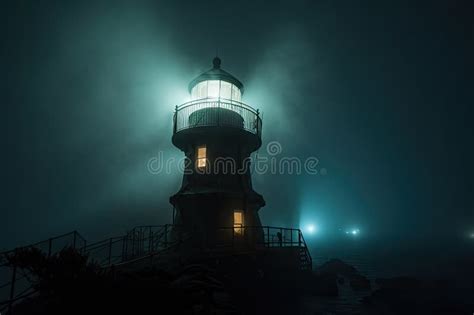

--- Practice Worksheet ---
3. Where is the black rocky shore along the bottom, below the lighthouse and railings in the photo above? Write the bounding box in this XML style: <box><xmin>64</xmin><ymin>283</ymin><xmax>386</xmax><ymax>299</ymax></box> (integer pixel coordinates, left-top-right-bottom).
<box><xmin>4</xmin><ymin>251</ymin><xmax>474</xmax><ymax>315</ymax></box>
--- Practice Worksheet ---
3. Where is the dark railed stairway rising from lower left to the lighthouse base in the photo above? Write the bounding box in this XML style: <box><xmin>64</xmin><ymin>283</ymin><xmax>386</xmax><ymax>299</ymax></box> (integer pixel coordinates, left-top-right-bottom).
<box><xmin>0</xmin><ymin>224</ymin><xmax>179</xmax><ymax>314</ymax></box>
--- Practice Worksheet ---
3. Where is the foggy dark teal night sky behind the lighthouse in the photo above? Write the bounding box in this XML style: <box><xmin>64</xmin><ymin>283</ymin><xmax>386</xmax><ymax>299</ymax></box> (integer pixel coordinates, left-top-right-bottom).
<box><xmin>0</xmin><ymin>0</ymin><xmax>474</xmax><ymax>249</ymax></box>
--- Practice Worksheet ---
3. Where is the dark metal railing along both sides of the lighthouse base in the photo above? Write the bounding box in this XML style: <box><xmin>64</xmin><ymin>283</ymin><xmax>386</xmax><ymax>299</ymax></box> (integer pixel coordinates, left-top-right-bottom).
<box><xmin>0</xmin><ymin>224</ymin><xmax>312</xmax><ymax>314</ymax></box>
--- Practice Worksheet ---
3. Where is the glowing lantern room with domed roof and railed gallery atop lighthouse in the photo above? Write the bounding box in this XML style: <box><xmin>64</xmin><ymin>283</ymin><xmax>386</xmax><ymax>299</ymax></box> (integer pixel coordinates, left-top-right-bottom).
<box><xmin>173</xmin><ymin>57</ymin><xmax>262</xmax><ymax>151</ymax></box>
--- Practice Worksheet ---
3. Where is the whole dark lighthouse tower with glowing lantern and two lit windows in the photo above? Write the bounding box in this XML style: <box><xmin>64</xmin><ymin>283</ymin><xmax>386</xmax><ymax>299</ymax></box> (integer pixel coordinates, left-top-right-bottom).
<box><xmin>170</xmin><ymin>57</ymin><xmax>265</xmax><ymax>246</ymax></box>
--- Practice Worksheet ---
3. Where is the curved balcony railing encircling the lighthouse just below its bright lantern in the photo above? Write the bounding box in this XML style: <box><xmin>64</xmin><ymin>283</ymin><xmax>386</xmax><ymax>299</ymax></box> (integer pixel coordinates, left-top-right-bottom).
<box><xmin>173</xmin><ymin>98</ymin><xmax>262</xmax><ymax>137</ymax></box>
